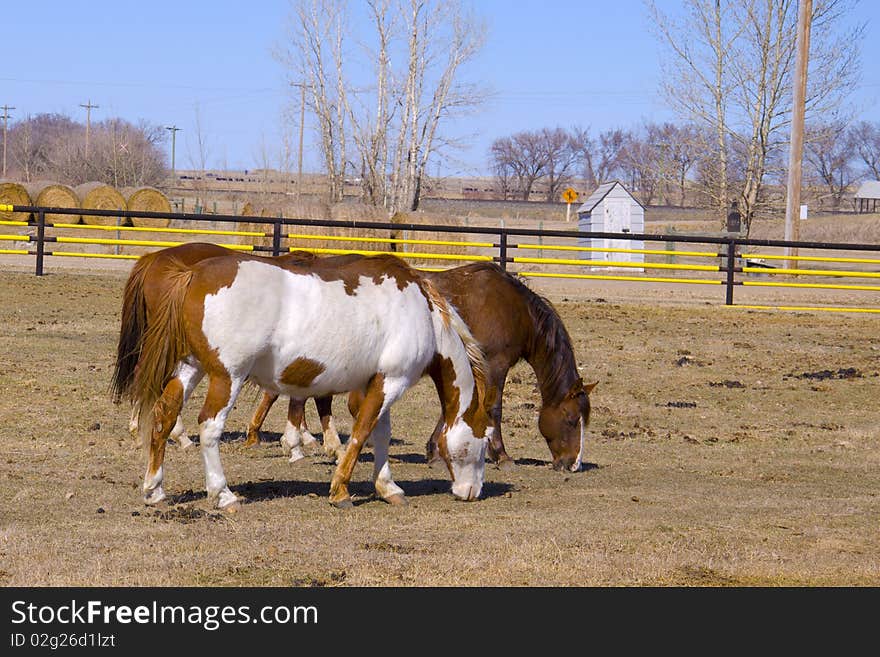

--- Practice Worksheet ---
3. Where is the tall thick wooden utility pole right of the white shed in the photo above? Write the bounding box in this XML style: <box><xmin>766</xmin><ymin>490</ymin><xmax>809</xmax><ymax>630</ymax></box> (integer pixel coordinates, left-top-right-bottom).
<box><xmin>785</xmin><ymin>0</ymin><xmax>813</xmax><ymax>269</ymax></box>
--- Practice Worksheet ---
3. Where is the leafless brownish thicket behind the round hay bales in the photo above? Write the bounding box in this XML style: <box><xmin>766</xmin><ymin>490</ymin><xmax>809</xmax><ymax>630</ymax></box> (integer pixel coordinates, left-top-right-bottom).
<box><xmin>6</xmin><ymin>114</ymin><xmax>167</xmax><ymax>187</ymax></box>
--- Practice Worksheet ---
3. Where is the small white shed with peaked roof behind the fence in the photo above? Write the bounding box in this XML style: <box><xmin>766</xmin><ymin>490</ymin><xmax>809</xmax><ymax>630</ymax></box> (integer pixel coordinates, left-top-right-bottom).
<box><xmin>577</xmin><ymin>181</ymin><xmax>645</xmax><ymax>271</ymax></box>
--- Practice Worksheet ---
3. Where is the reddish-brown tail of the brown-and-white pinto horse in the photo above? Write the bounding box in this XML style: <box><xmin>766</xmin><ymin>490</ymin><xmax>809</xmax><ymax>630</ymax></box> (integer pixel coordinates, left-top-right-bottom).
<box><xmin>129</xmin><ymin>258</ymin><xmax>193</xmax><ymax>441</ymax></box>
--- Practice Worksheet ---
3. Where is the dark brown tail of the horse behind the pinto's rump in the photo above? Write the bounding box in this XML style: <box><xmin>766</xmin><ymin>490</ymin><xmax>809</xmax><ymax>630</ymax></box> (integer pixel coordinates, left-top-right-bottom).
<box><xmin>110</xmin><ymin>251</ymin><xmax>158</xmax><ymax>403</ymax></box>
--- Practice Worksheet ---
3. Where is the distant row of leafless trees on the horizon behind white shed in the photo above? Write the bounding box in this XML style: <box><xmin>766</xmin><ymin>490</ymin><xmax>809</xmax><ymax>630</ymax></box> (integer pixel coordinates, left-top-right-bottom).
<box><xmin>489</xmin><ymin>121</ymin><xmax>880</xmax><ymax>209</ymax></box>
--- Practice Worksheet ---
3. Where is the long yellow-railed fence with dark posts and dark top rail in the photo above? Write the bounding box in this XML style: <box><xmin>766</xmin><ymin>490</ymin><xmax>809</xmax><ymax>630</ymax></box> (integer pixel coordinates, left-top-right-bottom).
<box><xmin>0</xmin><ymin>204</ymin><xmax>880</xmax><ymax>313</ymax></box>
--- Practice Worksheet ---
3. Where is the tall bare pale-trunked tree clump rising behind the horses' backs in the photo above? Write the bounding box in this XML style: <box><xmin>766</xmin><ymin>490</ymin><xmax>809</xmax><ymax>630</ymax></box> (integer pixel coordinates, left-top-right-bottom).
<box><xmin>279</xmin><ymin>0</ymin><xmax>485</xmax><ymax>214</ymax></box>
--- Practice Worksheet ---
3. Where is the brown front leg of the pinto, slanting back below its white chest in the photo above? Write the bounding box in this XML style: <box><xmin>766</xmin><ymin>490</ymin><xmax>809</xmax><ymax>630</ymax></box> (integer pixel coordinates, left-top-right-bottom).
<box><xmin>330</xmin><ymin>373</ymin><xmax>409</xmax><ymax>508</ymax></box>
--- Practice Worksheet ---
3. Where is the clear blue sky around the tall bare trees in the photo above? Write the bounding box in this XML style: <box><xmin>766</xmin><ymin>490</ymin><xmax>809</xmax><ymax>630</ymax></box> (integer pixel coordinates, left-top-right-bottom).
<box><xmin>6</xmin><ymin>0</ymin><xmax>880</xmax><ymax>175</ymax></box>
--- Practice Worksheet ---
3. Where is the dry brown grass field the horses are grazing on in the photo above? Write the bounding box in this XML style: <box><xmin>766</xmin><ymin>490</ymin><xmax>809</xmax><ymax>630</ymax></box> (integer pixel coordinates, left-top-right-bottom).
<box><xmin>0</xmin><ymin>255</ymin><xmax>880</xmax><ymax>586</ymax></box>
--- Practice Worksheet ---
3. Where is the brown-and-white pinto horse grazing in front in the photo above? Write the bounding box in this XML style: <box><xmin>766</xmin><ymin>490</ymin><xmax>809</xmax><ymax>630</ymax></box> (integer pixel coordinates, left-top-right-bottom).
<box><xmin>114</xmin><ymin>247</ymin><xmax>492</xmax><ymax>508</ymax></box>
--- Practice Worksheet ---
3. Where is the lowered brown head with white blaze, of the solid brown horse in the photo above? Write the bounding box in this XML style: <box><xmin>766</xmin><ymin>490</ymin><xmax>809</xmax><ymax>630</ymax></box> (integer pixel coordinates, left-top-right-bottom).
<box><xmin>538</xmin><ymin>379</ymin><xmax>598</xmax><ymax>472</ymax></box>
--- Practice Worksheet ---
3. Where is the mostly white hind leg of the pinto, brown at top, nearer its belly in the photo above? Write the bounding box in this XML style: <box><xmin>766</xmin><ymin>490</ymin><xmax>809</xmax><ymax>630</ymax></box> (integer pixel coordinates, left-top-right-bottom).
<box><xmin>199</xmin><ymin>374</ymin><xmax>243</xmax><ymax>511</ymax></box>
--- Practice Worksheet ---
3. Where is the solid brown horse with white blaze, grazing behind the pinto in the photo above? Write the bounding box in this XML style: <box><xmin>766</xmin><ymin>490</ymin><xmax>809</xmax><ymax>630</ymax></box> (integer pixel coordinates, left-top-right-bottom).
<box><xmin>249</xmin><ymin>263</ymin><xmax>596</xmax><ymax>471</ymax></box>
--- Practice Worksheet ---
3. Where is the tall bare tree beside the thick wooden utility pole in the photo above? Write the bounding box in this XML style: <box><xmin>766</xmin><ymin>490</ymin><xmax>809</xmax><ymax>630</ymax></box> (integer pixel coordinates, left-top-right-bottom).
<box><xmin>650</xmin><ymin>0</ymin><xmax>863</xmax><ymax>236</ymax></box>
